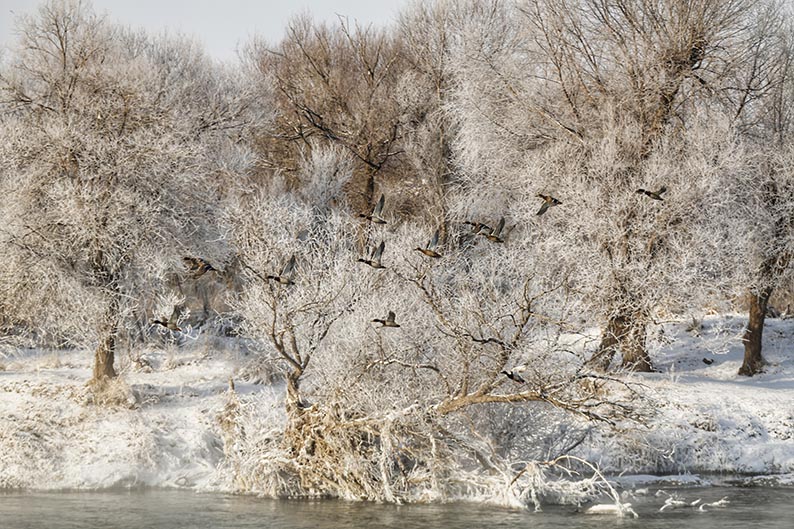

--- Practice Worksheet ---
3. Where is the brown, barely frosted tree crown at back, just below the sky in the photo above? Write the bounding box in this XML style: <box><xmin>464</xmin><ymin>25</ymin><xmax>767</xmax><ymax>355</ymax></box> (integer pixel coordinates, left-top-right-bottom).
<box><xmin>251</xmin><ymin>17</ymin><xmax>404</xmax><ymax>214</ymax></box>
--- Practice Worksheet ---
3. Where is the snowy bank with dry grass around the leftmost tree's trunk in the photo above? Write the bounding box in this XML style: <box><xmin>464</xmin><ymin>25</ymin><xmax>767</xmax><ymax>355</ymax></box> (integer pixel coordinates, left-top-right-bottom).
<box><xmin>0</xmin><ymin>340</ymin><xmax>252</xmax><ymax>489</ymax></box>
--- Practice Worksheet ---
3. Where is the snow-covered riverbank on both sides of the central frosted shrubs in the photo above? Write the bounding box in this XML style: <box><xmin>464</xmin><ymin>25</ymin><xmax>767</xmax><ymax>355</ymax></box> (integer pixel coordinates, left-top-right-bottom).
<box><xmin>0</xmin><ymin>315</ymin><xmax>794</xmax><ymax>491</ymax></box>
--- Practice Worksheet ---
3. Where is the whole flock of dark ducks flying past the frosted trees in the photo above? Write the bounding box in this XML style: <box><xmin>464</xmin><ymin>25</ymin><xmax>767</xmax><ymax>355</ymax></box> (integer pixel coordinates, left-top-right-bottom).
<box><xmin>152</xmin><ymin>186</ymin><xmax>667</xmax><ymax>384</ymax></box>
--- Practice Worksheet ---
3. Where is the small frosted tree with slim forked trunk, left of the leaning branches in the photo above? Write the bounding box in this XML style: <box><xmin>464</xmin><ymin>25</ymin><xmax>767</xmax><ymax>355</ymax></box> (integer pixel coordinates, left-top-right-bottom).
<box><xmin>226</xmin><ymin>148</ymin><xmax>357</xmax><ymax>414</ymax></box>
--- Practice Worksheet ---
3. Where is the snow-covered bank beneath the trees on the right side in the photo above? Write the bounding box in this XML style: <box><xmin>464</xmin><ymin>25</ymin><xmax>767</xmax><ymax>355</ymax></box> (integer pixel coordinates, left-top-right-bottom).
<box><xmin>580</xmin><ymin>315</ymin><xmax>794</xmax><ymax>483</ymax></box>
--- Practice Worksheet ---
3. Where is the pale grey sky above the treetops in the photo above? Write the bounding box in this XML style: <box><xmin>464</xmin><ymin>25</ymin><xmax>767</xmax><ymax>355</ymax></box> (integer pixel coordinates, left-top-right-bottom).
<box><xmin>0</xmin><ymin>0</ymin><xmax>409</xmax><ymax>60</ymax></box>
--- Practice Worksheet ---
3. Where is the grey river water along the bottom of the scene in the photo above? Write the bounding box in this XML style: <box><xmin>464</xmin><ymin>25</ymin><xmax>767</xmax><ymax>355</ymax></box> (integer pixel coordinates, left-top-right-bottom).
<box><xmin>0</xmin><ymin>487</ymin><xmax>794</xmax><ymax>529</ymax></box>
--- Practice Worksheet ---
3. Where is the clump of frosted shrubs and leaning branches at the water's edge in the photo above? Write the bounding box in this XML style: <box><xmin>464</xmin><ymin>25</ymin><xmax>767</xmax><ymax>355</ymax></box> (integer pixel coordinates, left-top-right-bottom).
<box><xmin>220</xmin><ymin>141</ymin><xmax>637</xmax><ymax>501</ymax></box>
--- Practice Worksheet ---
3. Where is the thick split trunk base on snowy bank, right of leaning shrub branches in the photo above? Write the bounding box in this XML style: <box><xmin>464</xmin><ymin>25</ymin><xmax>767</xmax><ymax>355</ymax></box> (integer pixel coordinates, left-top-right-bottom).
<box><xmin>587</xmin><ymin>313</ymin><xmax>653</xmax><ymax>372</ymax></box>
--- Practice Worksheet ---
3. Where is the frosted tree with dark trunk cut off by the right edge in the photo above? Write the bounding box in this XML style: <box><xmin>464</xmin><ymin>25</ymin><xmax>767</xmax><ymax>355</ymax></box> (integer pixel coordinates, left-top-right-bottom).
<box><xmin>715</xmin><ymin>9</ymin><xmax>794</xmax><ymax>376</ymax></box>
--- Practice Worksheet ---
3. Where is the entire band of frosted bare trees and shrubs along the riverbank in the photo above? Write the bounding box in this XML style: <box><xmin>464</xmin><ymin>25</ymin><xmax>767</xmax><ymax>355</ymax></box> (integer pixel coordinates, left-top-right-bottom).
<box><xmin>0</xmin><ymin>0</ymin><xmax>794</xmax><ymax>500</ymax></box>
